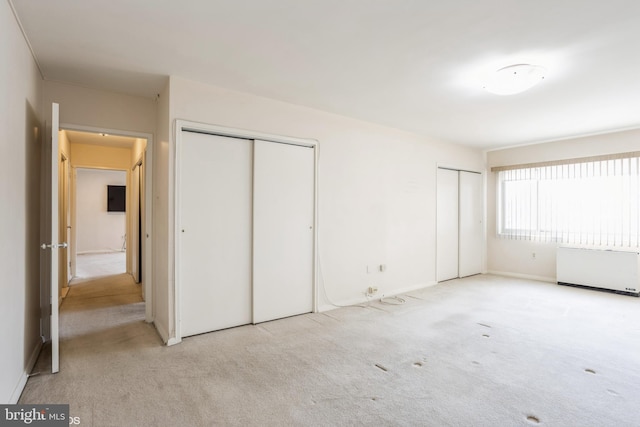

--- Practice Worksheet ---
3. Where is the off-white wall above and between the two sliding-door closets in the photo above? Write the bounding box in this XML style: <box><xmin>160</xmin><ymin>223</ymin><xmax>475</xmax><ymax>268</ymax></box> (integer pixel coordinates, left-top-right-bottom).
<box><xmin>156</xmin><ymin>77</ymin><xmax>484</xmax><ymax>344</ymax></box>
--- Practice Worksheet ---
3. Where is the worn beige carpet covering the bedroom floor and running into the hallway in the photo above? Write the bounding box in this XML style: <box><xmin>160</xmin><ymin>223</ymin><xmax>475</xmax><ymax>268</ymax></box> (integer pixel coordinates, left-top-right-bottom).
<box><xmin>20</xmin><ymin>276</ymin><xmax>640</xmax><ymax>426</ymax></box>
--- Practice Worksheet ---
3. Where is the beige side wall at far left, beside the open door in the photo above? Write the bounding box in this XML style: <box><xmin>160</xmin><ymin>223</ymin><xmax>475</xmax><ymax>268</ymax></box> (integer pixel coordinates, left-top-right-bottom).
<box><xmin>0</xmin><ymin>1</ymin><xmax>44</xmax><ymax>403</ymax></box>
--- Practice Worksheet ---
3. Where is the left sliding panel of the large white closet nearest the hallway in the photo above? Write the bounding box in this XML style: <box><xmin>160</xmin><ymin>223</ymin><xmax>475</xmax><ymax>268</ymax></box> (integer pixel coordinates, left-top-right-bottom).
<box><xmin>177</xmin><ymin>132</ymin><xmax>252</xmax><ymax>337</ymax></box>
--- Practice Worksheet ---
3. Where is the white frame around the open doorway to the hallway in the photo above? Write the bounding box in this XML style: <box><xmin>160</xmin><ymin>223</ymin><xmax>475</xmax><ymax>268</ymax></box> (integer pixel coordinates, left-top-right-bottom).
<box><xmin>60</xmin><ymin>123</ymin><xmax>155</xmax><ymax>323</ymax></box>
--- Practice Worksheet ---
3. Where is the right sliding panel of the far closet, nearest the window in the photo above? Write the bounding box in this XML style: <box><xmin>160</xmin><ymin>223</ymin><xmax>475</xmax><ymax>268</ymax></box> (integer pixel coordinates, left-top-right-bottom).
<box><xmin>458</xmin><ymin>171</ymin><xmax>484</xmax><ymax>277</ymax></box>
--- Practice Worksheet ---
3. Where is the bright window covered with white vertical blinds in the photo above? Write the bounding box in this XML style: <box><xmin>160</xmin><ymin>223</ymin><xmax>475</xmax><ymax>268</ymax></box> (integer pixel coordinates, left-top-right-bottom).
<box><xmin>493</xmin><ymin>153</ymin><xmax>640</xmax><ymax>247</ymax></box>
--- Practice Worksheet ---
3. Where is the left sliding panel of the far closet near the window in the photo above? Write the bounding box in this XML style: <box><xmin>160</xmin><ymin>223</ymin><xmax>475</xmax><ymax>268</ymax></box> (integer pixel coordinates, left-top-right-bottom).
<box><xmin>436</xmin><ymin>168</ymin><xmax>459</xmax><ymax>282</ymax></box>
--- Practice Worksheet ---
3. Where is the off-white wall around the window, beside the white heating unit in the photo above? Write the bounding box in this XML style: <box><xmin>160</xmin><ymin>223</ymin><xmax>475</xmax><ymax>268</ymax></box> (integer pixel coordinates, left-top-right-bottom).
<box><xmin>487</xmin><ymin>130</ymin><xmax>640</xmax><ymax>281</ymax></box>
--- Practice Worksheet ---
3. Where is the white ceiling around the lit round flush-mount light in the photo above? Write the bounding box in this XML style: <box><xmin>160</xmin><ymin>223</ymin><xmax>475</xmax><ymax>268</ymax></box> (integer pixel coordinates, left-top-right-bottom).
<box><xmin>10</xmin><ymin>0</ymin><xmax>640</xmax><ymax>148</ymax></box>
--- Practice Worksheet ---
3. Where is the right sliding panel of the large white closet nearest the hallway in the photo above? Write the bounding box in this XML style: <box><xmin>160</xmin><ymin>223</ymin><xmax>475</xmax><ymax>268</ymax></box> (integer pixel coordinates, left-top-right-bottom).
<box><xmin>253</xmin><ymin>141</ymin><xmax>314</xmax><ymax>323</ymax></box>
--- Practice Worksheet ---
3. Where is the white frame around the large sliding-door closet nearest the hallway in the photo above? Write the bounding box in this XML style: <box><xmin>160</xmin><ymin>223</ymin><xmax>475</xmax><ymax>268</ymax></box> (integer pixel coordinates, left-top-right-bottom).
<box><xmin>167</xmin><ymin>119</ymin><xmax>319</xmax><ymax>345</ymax></box>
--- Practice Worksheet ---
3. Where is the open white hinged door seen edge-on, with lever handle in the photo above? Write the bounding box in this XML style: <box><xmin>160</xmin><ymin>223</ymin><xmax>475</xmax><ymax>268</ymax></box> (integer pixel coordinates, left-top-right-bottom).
<box><xmin>41</xmin><ymin>103</ymin><xmax>62</xmax><ymax>373</ymax></box>
